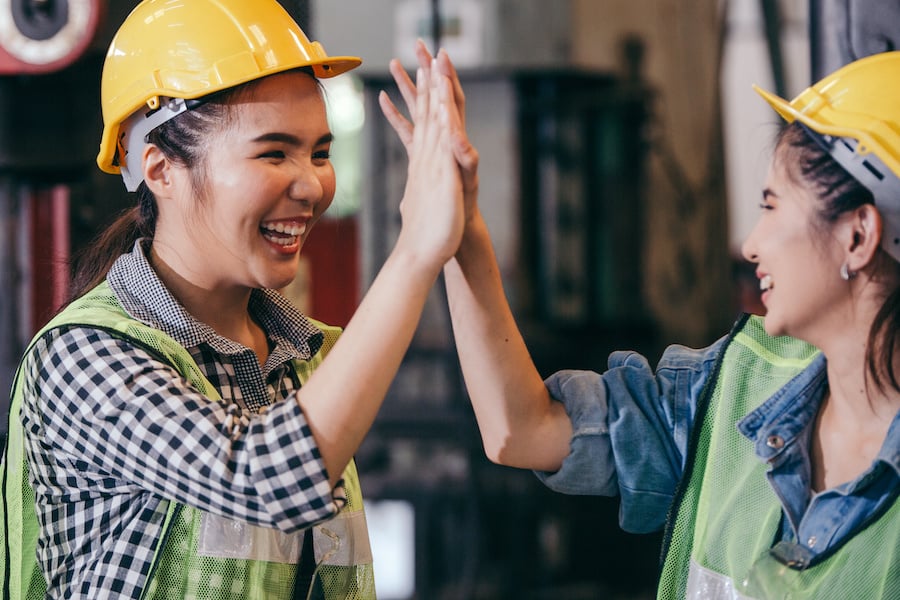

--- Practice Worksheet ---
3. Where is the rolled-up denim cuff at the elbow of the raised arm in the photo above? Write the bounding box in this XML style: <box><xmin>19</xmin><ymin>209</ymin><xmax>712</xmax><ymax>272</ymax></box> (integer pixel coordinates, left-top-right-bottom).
<box><xmin>534</xmin><ymin>371</ymin><xmax>619</xmax><ymax>496</ymax></box>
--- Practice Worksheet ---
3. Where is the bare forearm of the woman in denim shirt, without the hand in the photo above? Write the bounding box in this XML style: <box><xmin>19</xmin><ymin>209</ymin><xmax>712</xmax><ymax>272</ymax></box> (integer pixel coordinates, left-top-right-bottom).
<box><xmin>444</xmin><ymin>215</ymin><xmax>571</xmax><ymax>471</ymax></box>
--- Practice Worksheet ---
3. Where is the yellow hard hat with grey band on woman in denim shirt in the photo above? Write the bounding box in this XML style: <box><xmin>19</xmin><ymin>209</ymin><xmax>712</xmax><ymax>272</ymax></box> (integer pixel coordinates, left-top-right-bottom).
<box><xmin>753</xmin><ymin>51</ymin><xmax>900</xmax><ymax>261</ymax></box>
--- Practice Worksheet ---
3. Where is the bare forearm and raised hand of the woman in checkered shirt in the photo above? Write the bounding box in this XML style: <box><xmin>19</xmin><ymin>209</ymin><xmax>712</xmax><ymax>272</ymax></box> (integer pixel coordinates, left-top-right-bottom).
<box><xmin>297</xmin><ymin>55</ymin><xmax>465</xmax><ymax>483</ymax></box>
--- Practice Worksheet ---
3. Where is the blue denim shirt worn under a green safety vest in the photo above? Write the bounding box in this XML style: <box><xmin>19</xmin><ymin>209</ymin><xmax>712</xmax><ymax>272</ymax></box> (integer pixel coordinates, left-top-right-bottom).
<box><xmin>536</xmin><ymin>338</ymin><xmax>900</xmax><ymax>562</ymax></box>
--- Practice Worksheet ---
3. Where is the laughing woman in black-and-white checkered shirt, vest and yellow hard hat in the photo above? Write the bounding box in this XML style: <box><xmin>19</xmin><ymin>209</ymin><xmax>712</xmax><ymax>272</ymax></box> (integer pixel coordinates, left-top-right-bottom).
<box><xmin>3</xmin><ymin>0</ymin><xmax>463</xmax><ymax>599</ymax></box>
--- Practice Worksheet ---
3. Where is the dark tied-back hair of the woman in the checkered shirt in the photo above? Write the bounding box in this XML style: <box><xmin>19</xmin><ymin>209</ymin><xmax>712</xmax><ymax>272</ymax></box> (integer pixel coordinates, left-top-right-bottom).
<box><xmin>67</xmin><ymin>67</ymin><xmax>315</xmax><ymax>304</ymax></box>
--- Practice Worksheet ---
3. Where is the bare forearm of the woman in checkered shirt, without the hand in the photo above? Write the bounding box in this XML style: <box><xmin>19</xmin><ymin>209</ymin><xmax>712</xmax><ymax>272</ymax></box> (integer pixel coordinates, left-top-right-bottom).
<box><xmin>297</xmin><ymin>248</ymin><xmax>440</xmax><ymax>483</ymax></box>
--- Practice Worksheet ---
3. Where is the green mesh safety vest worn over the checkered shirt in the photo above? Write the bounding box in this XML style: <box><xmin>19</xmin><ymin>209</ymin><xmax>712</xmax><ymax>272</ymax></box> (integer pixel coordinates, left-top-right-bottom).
<box><xmin>0</xmin><ymin>282</ymin><xmax>375</xmax><ymax>600</ymax></box>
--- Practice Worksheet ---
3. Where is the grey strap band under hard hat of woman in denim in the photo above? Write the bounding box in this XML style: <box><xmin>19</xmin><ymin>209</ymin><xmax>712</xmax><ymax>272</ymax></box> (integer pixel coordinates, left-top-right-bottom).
<box><xmin>801</xmin><ymin>123</ymin><xmax>900</xmax><ymax>262</ymax></box>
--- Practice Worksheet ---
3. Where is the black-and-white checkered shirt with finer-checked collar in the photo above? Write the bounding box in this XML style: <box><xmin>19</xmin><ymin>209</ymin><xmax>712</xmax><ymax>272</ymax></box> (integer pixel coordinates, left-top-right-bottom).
<box><xmin>21</xmin><ymin>243</ymin><xmax>345</xmax><ymax>600</ymax></box>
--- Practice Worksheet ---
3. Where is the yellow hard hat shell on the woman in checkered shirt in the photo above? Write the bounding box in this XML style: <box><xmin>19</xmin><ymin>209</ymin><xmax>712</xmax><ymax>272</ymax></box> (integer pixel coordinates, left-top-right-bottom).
<box><xmin>97</xmin><ymin>0</ymin><xmax>362</xmax><ymax>183</ymax></box>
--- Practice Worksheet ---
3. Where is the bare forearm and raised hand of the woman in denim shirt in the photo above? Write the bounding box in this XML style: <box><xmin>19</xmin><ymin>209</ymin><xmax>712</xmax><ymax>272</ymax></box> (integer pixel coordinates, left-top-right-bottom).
<box><xmin>379</xmin><ymin>41</ymin><xmax>572</xmax><ymax>471</ymax></box>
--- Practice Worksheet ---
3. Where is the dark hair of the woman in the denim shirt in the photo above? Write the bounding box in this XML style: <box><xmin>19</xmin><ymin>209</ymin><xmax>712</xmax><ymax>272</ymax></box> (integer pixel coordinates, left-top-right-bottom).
<box><xmin>775</xmin><ymin>122</ymin><xmax>900</xmax><ymax>391</ymax></box>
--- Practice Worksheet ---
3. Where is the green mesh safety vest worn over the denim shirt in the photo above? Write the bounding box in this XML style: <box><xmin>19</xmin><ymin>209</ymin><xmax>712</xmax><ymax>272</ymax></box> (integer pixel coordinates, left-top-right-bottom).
<box><xmin>658</xmin><ymin>317</ymin><xmax>900</xmax><ymax>600</ymax></box>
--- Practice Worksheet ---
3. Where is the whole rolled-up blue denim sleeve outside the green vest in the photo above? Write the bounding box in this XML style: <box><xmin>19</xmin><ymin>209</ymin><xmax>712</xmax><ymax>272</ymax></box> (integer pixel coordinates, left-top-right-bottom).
<box><xmin>535</xmin><ymin>340</ymin><xmax>723</xmax><ymax>533</ymax></box>
